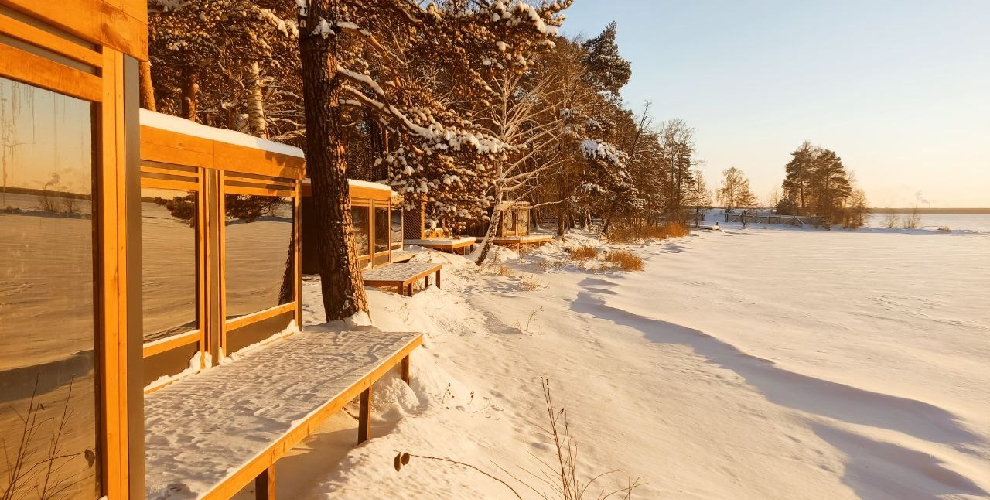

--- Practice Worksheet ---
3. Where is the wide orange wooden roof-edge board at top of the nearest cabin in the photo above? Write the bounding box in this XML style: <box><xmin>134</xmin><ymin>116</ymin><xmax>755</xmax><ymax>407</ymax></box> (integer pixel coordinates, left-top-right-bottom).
<box><xmin>3</xmin><ymin>0</ymin><xmax>148</xmax><ymax>61</ymax></box>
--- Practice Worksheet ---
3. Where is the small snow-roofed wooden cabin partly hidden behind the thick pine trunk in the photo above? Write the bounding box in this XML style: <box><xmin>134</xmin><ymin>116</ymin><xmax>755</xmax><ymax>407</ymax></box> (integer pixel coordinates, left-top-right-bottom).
<box><xmin>302</xmin><ymin>180</ymin><xmax>411</xmax><ymax>274</ymax></box>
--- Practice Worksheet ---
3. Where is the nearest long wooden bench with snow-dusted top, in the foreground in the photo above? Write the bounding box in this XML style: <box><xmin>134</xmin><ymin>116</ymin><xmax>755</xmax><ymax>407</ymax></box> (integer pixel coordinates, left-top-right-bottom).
<box><xmin>144</xmin><ymin>327</ymin><xmax>423</xmax><ymax>500</ymax></box>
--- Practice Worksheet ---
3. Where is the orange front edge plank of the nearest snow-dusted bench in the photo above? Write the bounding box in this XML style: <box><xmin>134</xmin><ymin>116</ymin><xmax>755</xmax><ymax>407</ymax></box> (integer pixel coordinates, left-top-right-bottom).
<box><xmin>201</xmin><ymin>336</ymin><xmax>423</xmax><ymax>500</ymax></box>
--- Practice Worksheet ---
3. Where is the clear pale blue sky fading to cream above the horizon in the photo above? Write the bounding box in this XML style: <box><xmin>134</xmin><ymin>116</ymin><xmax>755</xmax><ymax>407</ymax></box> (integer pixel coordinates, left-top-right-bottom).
<box><xmin>563</xmin><ymin>0</ymin><xmax>990</xmax><ymax>207</ymax></box>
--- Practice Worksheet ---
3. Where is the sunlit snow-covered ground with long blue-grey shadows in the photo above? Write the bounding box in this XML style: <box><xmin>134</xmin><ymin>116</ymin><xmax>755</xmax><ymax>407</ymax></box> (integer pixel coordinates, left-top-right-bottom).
<box><xmin>236</xmin><ymin>224</ymin><xmax>990</xmax><ymax>500</ymax></box>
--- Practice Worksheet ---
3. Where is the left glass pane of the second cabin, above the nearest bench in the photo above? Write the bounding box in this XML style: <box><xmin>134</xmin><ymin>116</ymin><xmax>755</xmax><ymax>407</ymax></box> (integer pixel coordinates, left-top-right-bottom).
<box><xmin>141</xmin><ymin>187</ymin><xmax>199</xmax><ymax>342</ymax></box>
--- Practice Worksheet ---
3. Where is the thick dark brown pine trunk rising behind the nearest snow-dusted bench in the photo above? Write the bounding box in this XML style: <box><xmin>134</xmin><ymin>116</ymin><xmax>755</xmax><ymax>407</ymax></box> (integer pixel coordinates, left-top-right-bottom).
<box><xmin>299</xmin><ymin>4</ymin><xmax>368</xmax><ymax>321</ymax></box>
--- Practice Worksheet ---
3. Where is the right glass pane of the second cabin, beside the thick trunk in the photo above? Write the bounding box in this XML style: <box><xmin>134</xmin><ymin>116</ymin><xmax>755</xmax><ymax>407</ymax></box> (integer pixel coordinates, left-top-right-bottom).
<box><xmin>224</xmin><ymin>194</ymin><xmax>293</xmax><ymax>319</ymax></box>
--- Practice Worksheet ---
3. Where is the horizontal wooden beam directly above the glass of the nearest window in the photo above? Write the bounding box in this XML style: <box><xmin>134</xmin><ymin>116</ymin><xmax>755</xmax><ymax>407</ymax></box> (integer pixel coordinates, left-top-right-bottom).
<box><xmin>0</xmin><ymin>43</ymin><xmax>104</xmax><ymax>102</ymax></box>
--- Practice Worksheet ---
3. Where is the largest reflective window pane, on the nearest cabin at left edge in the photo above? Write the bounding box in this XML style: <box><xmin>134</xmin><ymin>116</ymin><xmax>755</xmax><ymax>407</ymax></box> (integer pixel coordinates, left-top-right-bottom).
<box><xmin>0</xmin><ymin>77</ymin><xmax>100</xmax><ymax>499</ymax></box>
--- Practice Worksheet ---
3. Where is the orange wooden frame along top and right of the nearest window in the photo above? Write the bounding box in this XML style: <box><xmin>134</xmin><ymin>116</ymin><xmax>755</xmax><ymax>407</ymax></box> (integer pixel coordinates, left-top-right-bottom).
<box><xmin>0</xmin><ymin>10</ymin><xmax>136</xmax><ymax>500</ymax></box>
